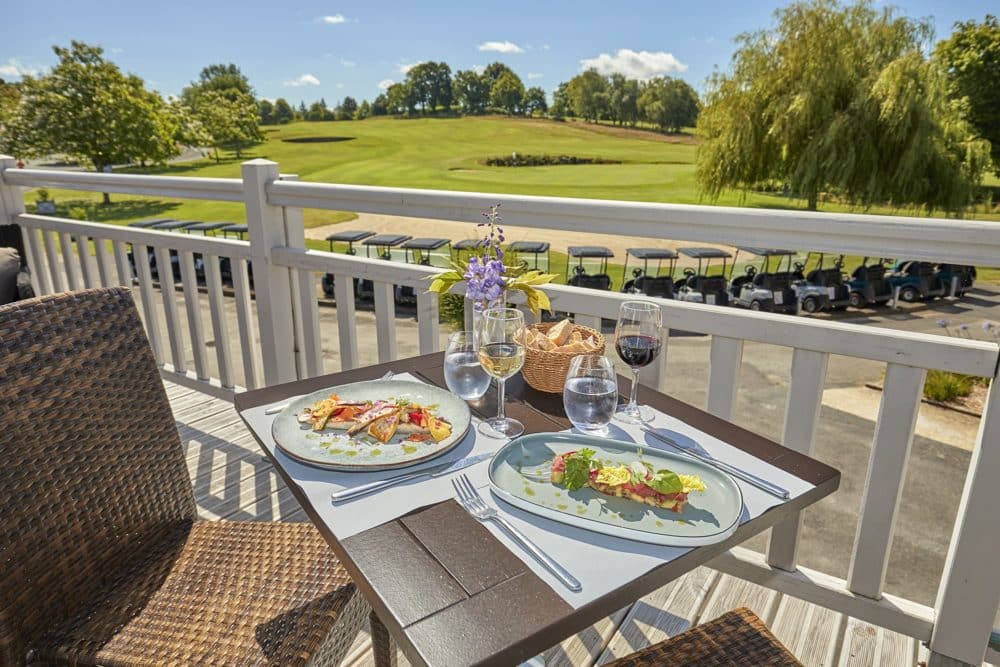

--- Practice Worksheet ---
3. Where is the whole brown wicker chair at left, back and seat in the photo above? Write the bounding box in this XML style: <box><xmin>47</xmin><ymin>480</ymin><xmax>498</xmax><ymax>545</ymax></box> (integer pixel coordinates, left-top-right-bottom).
<box><xmin>0</xmin><ymin>288</ymin><xmax>368</xmax><ymax>665</ymax></box>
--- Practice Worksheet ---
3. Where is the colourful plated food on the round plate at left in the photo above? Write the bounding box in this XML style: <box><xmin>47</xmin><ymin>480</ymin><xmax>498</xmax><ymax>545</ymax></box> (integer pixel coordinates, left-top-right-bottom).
<box><xmin>298</xmin><ymin>394</ymin><xmax>452</xmax><ymax>444</ymax></box>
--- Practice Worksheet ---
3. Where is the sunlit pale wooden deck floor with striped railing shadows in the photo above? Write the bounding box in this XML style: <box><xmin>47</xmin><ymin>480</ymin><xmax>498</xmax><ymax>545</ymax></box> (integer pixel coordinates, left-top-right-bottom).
<box><xmin>165</xmin><ymin>382</ymin><xmax>927</xmax><ymax>667</ymax></box>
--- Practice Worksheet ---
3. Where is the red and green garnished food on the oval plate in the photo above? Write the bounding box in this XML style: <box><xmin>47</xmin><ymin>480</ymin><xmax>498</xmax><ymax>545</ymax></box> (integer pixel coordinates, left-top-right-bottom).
<box><xmin>550</xmin><ymin>448</ymin><xmax>705</xmax><ymax>513</ymax></box>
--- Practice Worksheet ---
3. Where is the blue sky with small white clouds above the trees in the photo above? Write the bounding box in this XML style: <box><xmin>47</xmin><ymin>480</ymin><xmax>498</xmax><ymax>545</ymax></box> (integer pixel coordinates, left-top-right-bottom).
<box><xmin>0</xmin><ymin>0</ymin><xmax>1000</xmax><ymax>106</ymax></box>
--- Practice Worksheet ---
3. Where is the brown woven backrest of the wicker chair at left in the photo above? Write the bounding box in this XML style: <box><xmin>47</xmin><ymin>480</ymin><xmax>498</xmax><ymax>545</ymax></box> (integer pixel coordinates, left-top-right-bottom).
<box><xmin>0</xmin><ymin>288</ymin><xmax>195</xmax><ymax>665</ymax></box>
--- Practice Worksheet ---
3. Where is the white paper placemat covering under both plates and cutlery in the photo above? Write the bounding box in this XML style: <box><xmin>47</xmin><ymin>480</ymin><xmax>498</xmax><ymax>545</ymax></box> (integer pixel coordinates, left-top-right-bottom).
<box><xmin>242</xmin><ymin>373</ymin><xmax>813</xmax><ymax>608</ymax></box>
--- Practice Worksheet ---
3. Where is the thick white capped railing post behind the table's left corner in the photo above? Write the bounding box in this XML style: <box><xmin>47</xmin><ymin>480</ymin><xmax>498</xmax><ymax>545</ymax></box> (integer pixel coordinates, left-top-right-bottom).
<box><xmin>242</xmin><ymin>159</ymin><xmax>295</xmax><ymax>385</ymax></box>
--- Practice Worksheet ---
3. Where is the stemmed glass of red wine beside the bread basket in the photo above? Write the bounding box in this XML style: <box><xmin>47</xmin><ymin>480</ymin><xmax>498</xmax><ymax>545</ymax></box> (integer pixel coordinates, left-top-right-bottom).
<box><xmin>615</xmin><ymin>301</ymin><xmax>663</xmax><ymax>424</ymax></box>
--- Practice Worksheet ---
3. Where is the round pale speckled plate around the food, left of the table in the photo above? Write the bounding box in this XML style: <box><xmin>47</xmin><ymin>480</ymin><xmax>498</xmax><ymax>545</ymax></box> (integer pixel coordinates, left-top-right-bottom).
<box><xmin>271</xmin><ymin>380</ymin><xmax>472</xmax><ymax>471</ymax></box>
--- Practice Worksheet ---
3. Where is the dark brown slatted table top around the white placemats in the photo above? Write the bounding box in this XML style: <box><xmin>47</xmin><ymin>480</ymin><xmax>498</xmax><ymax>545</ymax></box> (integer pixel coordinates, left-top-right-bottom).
<box><xmin>235</xmin><ymin>353</ymin><xmax>840</xmax><ymax>665</ymax></box>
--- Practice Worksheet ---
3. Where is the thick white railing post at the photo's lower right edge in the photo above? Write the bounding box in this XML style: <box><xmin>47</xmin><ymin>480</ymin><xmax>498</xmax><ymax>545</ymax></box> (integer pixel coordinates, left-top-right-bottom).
<box><xmin>931</xmin><ymin>377</ymin><xmax>1000</xmax><ymax>665</ymax></box>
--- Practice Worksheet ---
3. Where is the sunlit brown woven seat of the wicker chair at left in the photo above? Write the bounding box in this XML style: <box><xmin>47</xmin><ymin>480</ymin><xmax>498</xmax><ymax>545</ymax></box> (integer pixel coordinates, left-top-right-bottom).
<box><xmin>31</xmin><ymin>521</ymin><xmax>368</xmax><ymax>666</ymax></box>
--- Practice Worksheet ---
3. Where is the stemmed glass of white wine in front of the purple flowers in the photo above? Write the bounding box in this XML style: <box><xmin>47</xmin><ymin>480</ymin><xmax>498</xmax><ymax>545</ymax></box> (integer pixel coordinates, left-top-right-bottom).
<box><xmin>479</xmin><ymin>308</ymin><xmax>524</xmax><ymax>438</ymax></box>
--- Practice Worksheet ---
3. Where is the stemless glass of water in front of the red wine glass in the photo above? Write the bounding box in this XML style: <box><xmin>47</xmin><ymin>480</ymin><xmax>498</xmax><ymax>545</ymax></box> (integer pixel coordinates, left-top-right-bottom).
<box><xmin>563</xmin><ymin>355</ymin><xmax>618</xmax><ymax>435</ymax></box>
